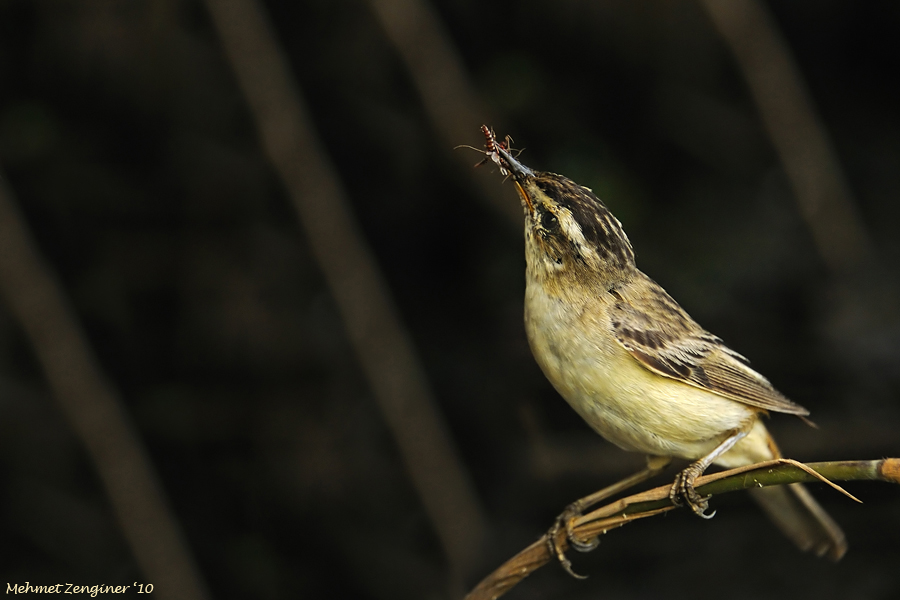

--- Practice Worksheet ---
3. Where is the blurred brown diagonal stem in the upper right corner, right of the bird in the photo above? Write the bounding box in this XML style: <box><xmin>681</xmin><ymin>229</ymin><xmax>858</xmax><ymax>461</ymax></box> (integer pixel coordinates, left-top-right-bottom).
<box><xmin>702</xmin><ymin>0</ymin><xmax>875</xmax><ymax>278</ymax></box>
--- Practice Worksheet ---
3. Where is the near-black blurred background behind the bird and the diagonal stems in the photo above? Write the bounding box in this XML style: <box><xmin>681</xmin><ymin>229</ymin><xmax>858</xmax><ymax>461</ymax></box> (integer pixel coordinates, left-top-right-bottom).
<box><xmin>0</xmin><ymin>0</ymin><xmax>900</xmax><ymax>599</ymax></box>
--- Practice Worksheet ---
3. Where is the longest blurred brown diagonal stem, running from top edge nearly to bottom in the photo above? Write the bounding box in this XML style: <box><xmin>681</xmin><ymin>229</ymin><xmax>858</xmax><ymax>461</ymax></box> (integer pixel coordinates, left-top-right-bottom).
<box><xmin>206</xmin><ymin>0</ymin><xmax>486</xmax><ymax>579</ymax></box>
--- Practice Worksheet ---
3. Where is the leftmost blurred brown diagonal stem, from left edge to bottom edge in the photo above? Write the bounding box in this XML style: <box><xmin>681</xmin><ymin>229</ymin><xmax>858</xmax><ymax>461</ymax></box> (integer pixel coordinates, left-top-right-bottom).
<box><xmin>0</xmin><ymin>171</ymin><xmax>209</xmax><ymax>600</ymax></box>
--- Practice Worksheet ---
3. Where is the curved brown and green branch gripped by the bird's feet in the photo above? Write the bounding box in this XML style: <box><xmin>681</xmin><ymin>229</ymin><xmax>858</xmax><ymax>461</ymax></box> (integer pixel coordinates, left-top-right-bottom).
<box><xmin>465</xmin><ymin>458</ymin><xmax>900</xmax><ymax>600</ymax></box>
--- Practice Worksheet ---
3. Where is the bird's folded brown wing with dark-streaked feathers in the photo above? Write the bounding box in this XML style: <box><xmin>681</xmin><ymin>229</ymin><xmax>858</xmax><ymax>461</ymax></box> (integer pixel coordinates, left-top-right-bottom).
<box><xmin>609</xmin><ymin>277</ymin><xmax>809</xmax><ymax>416</ymax></box>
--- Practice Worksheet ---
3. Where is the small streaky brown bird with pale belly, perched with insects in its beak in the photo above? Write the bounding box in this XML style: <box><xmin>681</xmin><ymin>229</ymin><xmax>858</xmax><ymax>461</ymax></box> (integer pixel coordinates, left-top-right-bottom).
<box><xmin>483</xmin><ymin>127</ymin><xmax>847</xmax><ymax>565</ymax></box>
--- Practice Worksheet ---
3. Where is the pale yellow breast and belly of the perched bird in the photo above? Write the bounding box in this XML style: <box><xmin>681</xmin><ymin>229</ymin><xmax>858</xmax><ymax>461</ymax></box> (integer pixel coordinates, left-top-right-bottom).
<box><xmin>526</xmin><ymin>289</ymin><xmax>771</xmax><ymax>466</ymax></box>
